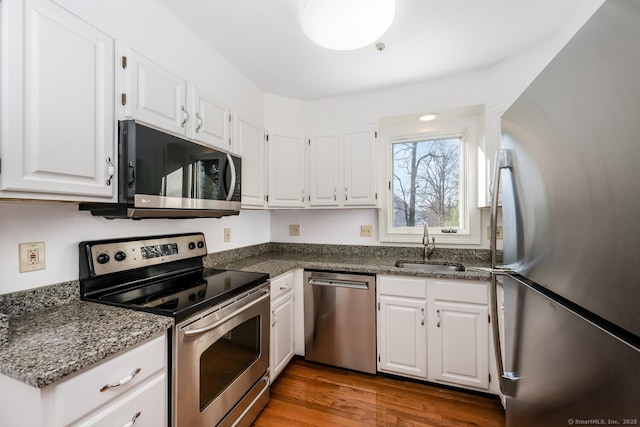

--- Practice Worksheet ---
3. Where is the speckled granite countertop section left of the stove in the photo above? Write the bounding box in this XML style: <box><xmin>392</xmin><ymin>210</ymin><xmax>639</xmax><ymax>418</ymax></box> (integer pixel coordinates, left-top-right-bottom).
<box><xmin>0</xmin><ymin>300</ymin><xmax>173</xmax><ymax>388</ymax></box>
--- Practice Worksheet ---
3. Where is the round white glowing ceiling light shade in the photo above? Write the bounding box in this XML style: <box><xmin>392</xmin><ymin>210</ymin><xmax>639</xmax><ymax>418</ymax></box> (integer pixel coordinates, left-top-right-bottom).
<box><xmin>300</xmin><ymin>0</ymin><xmax>396</xmax><ymax>50</ymax></box>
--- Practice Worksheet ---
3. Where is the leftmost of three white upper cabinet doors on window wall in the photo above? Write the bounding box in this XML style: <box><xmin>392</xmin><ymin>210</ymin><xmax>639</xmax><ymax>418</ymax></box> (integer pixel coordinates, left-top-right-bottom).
<box><xmin>267</xmin><ymin>132</ymin><xmax>307</xmax><ymax>208</ymax></box>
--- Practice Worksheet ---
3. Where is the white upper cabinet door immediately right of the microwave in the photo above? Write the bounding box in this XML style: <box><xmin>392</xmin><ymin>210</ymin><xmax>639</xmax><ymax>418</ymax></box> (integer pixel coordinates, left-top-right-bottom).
<box><xmin>235</xmin><ymin>115</ymin><xmax>267</xmax><ymax>208</ymax></box>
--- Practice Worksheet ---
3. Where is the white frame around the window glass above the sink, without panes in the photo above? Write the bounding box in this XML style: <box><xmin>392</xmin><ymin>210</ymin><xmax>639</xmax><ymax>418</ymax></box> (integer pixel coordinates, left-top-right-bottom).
<box><xmin>378</xmin><ymin>117</ymin><xmax>482</xmax><ymax>247</ymax></box>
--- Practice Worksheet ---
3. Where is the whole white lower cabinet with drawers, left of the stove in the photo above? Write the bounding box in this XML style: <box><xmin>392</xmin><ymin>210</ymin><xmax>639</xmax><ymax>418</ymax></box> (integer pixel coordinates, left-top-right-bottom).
<box><xmin>0</xmin><ymin>333</ymin><xmax>169</xmax><ymax>427</ymax></box>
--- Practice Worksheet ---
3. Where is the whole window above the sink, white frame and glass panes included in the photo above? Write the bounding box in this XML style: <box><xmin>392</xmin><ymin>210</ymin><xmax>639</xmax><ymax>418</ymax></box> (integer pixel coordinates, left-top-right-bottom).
<box><xmin>380</xmin><ymin>116</ymin><xmax>481</xmax><ymax>247</ymax></box>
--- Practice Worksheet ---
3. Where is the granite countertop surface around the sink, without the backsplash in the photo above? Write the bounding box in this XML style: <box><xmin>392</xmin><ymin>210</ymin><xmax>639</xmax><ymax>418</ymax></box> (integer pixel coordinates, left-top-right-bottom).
<box><xmin>211</xmin><ymin>251</ymin><xmax>491</xmax><ymax>281</ymax></box>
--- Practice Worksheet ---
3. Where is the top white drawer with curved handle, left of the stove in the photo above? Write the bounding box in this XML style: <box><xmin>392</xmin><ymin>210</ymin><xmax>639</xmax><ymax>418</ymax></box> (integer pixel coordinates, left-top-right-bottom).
<box><xmin>53</xmin><ymin>334</ymin><xmax>167</xmax><ymax>425</ymax></box>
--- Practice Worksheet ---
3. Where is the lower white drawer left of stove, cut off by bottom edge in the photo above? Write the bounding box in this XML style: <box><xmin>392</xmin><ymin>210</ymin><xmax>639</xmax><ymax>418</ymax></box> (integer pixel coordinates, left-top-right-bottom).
<box><xmin>73</xmin><ymin>373</ymin><xmax>168</xmax><ymax>427</ymax></box>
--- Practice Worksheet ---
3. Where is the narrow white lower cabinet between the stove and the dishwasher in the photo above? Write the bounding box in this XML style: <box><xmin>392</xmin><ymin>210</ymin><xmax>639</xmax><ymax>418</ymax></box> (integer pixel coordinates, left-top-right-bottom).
<box><xmin>269</xmin><ymin>270</ymin><xmax>295</xmax><ymax>382</ymax></box>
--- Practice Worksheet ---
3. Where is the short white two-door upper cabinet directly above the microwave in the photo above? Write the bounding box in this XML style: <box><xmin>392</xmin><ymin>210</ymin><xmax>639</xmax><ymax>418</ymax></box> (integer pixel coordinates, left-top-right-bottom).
<box><xmin>121</xmin><ymin>48</ymin><xmax>232</xmax><ymax>151</ymax></box>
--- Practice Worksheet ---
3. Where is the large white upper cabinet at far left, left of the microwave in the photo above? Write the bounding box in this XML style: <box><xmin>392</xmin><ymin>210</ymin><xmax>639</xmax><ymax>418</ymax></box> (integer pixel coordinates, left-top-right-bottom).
<box><xmin>0</xmin><ymin>0</ymin><xmax>115</xmax><ymax>201</ymax></box>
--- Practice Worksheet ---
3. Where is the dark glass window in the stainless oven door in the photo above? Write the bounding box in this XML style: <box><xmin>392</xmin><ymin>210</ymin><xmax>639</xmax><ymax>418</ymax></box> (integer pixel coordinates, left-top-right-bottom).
<box><xmin>200</xmin><ymin>316</ymin><xmax>260</xmax><ymax>412</ymax></box>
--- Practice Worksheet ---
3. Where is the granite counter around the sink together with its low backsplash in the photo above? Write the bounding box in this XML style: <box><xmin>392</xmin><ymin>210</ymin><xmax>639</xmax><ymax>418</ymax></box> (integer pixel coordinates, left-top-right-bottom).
<box><xmin>207</xmin><ymin>244</ymin><xmax>491</xmax><ymax>280</ymax></box>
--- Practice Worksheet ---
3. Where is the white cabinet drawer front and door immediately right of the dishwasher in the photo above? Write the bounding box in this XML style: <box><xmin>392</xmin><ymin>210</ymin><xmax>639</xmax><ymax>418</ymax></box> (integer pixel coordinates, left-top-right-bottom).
<box><xmin>376</xmin><ymin>276</ymin><xmax>427</xmax><ymax>379</ymax></box>
